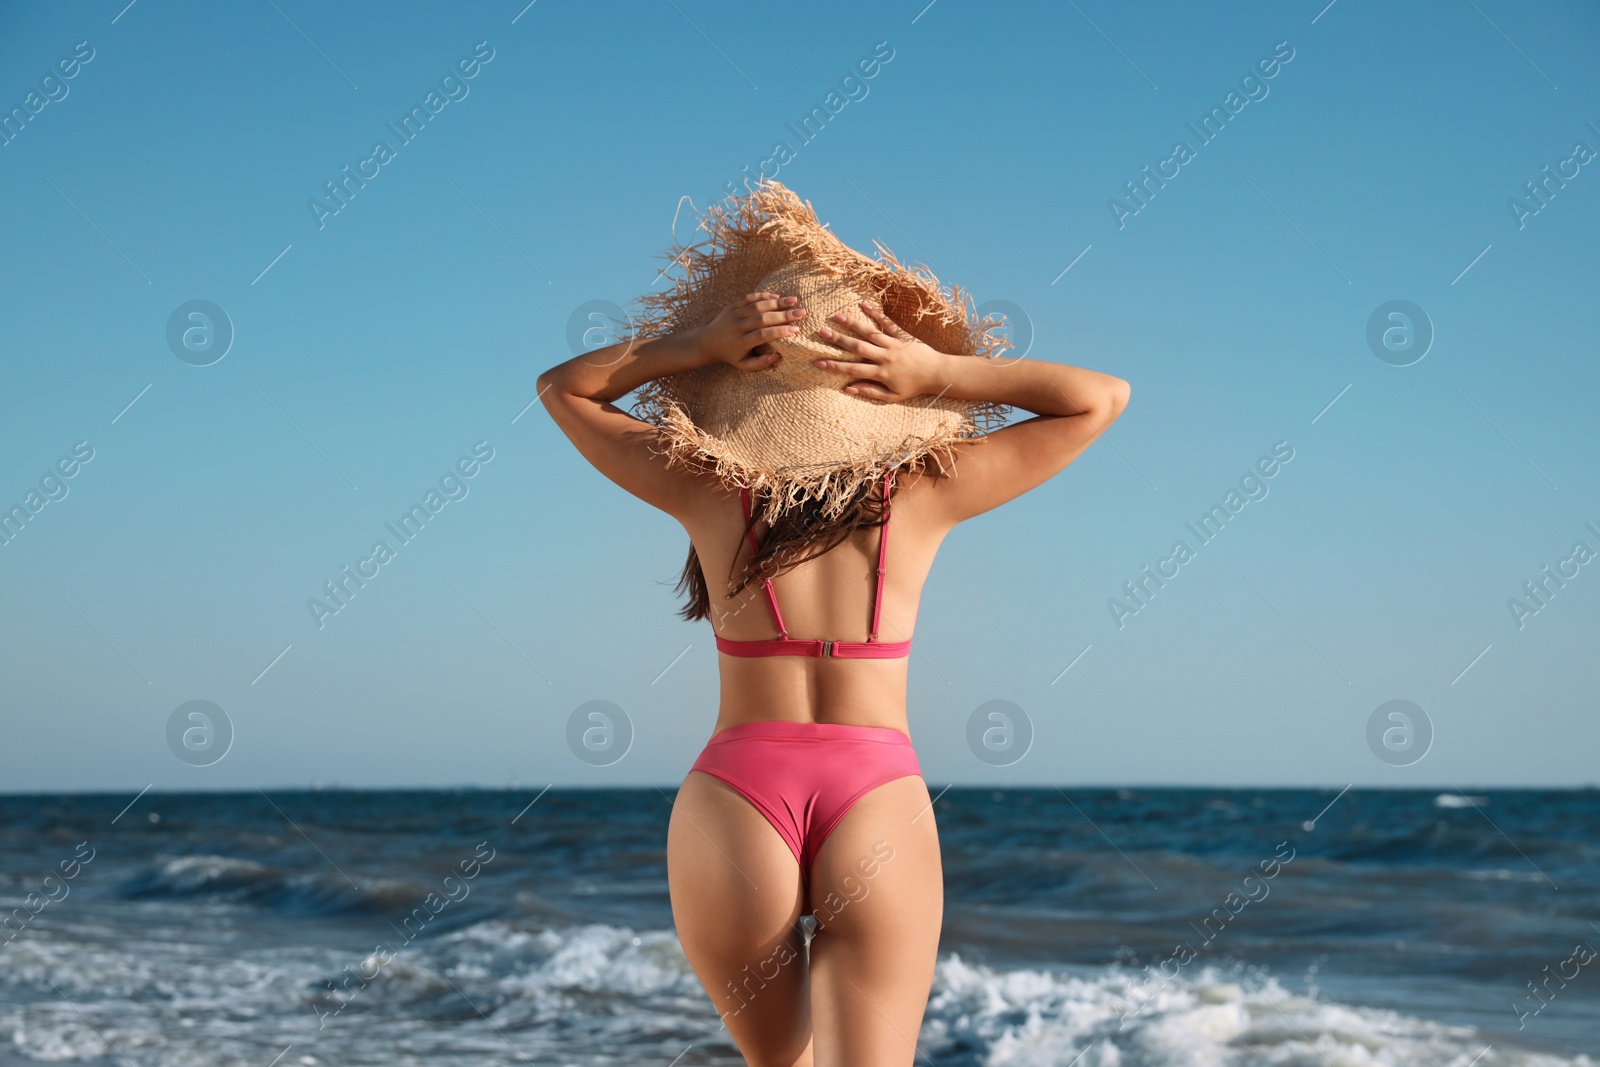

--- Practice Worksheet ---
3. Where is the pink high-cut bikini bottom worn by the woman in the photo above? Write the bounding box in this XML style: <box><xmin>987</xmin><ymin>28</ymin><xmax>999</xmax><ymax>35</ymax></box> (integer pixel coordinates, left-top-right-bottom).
<box><xmin>691</xmin><ymin>721</ymin><xmax>922</xmax><ymax>885</ymax></box>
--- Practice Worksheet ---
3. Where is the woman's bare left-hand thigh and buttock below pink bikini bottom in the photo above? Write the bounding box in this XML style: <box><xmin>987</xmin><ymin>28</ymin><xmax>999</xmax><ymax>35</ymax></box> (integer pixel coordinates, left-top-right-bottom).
<box><xmin>667</xmin><ymin>771</ymin><xmax>811</xmax><ymax>1067</ymax></box>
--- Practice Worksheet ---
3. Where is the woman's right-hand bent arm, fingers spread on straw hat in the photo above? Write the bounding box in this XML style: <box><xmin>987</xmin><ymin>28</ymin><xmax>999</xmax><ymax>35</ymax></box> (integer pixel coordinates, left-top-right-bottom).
<box><xmin>818</xmin><ymin>304</ymin><xmax>1131</xmax><ymax>526</ymax></box>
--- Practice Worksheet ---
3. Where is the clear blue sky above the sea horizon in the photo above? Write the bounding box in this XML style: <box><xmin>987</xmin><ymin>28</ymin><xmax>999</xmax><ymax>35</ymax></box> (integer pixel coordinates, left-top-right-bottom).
<box><xmin>0</xmin><ymin>0</ymin><xmax>1600</xmax><ymax>792</ymax></box>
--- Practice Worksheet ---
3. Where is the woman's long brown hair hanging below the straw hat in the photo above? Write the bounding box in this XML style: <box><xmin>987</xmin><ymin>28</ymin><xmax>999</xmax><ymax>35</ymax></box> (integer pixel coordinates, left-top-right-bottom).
<box><xmin>675</xmin><ymin>480</ymin><xmax>894</xmax><ymax>622</ymax></box>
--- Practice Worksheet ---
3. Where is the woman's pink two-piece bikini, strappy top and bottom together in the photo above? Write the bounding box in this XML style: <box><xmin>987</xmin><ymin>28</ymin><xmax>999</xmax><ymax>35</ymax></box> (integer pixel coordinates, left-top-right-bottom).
<box><xmin>691</xmin><ymin>475</ymin><xmax>922</xmax><ymax>885</ymax></box>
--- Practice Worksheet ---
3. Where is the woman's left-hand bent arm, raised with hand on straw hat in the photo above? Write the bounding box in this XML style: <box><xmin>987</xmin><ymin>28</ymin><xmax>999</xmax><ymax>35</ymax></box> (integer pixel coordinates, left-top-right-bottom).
<box><xmin>539</xmin><ymin>293</ymin><xmax>805</xmax><ymax>518</ymax></box>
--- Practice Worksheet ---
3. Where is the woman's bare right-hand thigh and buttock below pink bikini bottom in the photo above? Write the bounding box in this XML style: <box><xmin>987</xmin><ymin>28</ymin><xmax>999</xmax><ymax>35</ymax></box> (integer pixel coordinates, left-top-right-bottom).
<box><xmin>811</xmin><ymin>777</ymin><xmax>944</xmax><ymax>1067</ymax></box>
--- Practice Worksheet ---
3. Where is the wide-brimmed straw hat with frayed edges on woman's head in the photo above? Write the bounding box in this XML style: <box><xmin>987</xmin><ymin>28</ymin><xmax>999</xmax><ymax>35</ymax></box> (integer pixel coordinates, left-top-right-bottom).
<box><xmin>632</xmin><ymin>181</ymin><xmax>1010</xmax><ymax>522</ymax></box>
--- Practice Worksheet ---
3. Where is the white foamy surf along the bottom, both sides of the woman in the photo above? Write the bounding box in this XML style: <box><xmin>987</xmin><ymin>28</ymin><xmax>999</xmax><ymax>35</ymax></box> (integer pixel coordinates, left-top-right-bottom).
<box><xmin>0</xmin><ymin>918</ymin><xmax>1600</xmax><ymax>1067</ymax></box>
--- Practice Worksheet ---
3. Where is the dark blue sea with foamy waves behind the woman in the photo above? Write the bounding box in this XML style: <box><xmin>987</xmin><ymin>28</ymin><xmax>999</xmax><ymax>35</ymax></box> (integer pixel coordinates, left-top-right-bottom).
<box><xmin>0</xmin><ymin>787</ymin><xmax>1600</xmax><ymax>1067</ymax></box>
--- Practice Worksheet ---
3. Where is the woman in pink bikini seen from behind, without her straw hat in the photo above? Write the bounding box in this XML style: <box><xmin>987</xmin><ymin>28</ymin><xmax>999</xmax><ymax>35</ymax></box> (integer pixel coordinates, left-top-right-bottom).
<box><xmin>539</xmin><ymin>293</ymin><xmax>1128</xmax><ymax>1067</ymax></box>
